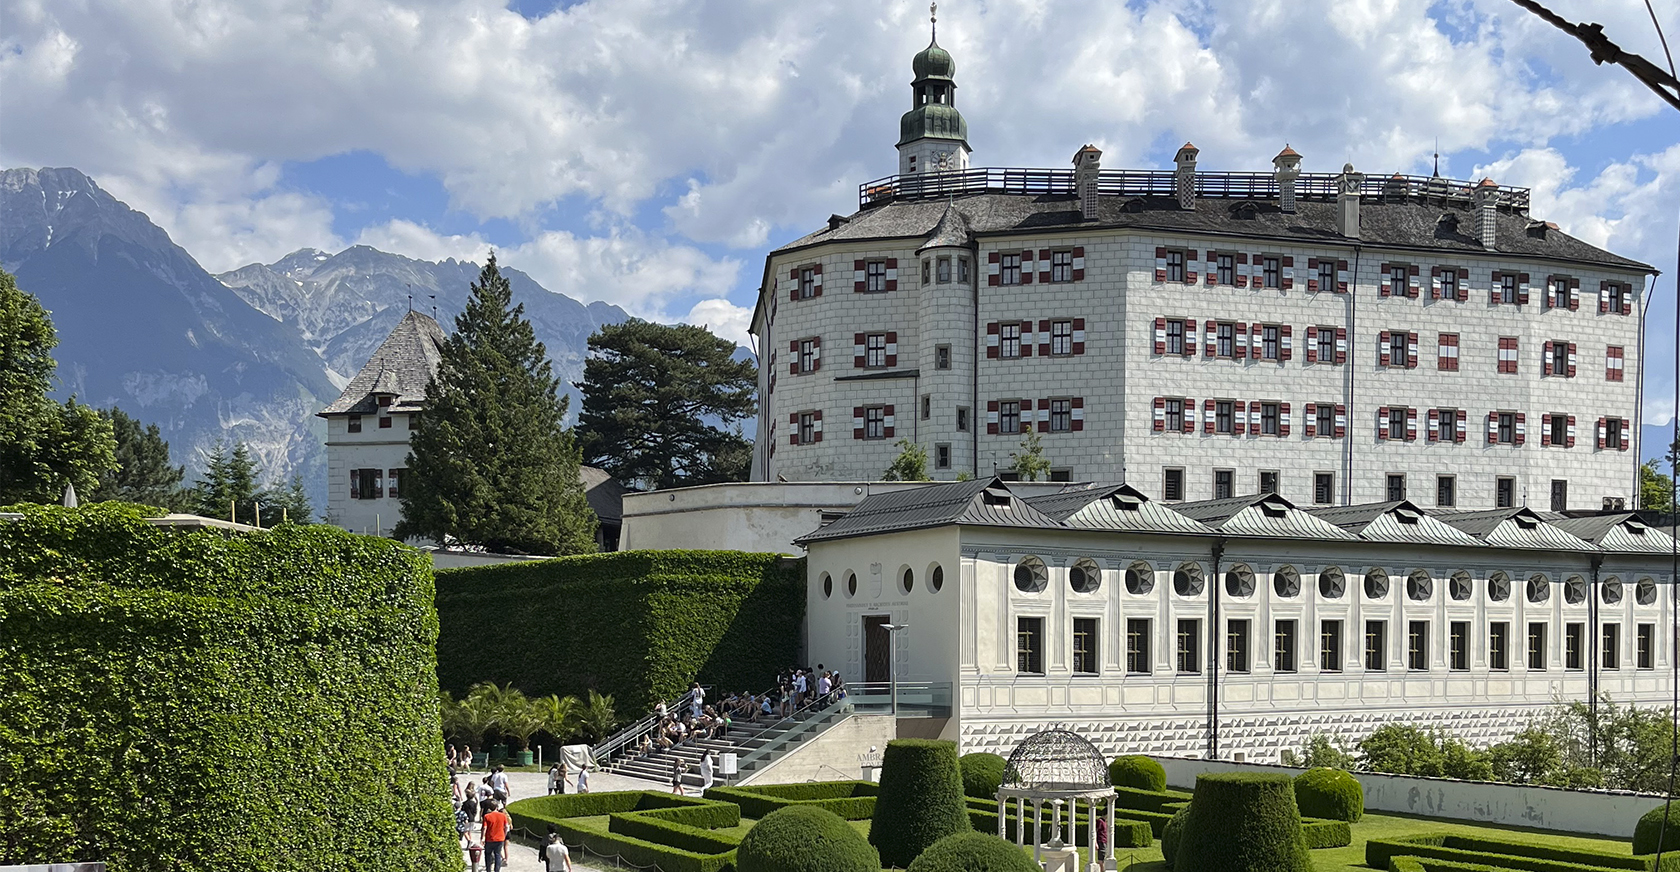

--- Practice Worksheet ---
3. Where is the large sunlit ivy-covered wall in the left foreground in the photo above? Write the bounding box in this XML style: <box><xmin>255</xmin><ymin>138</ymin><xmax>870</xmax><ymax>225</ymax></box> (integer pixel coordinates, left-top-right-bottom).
<box><xmin>0</xmin><ymin>502</ymin><xmax>460</xmax><ymax>872</ymax></box>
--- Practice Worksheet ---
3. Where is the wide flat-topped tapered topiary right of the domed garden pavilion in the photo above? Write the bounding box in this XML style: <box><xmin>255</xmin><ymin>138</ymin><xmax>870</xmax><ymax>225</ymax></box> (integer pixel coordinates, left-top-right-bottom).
<box><xmin>1173</xmin><ymin>773</ymin><xmax>1312</xmax><ymax>872</ymax></box>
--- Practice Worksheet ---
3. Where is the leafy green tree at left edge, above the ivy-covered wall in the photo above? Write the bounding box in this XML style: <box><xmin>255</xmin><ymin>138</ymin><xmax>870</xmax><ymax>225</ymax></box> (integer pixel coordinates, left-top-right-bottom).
<box><xmin>0</xmin><ymin>271</ymin><xmax>116</xmax><ymax>504</ymax></box>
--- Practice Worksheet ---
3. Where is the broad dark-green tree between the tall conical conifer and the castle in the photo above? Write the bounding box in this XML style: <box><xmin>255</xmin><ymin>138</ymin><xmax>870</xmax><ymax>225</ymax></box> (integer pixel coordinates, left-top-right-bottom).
<box><xmin>578</xmin><ymin>318</ymin><xmax>758</xmax><ymax>487</ymax></box>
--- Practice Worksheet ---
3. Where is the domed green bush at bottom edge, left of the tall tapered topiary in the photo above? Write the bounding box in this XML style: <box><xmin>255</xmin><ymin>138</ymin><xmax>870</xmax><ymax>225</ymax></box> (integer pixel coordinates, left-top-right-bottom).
<box><xmin>736</xmin><ymin>805</ymin><xmax>880</xmax><ymax>872</ymax></box>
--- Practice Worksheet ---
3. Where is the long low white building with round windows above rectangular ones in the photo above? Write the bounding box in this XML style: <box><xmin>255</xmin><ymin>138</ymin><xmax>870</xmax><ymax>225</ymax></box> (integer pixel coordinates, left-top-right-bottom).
<box><xmin>801</xmin><ymin>479</ymin><xmax>1675</xmax><ymax>761</ymax></box>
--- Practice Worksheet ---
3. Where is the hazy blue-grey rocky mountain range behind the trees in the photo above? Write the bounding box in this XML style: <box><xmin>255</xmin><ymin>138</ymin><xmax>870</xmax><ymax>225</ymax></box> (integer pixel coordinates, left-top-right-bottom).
<box><xmin>0</xmin><ymin>168</ymin><xmax>628</xmax><ymax>507</ymax></box>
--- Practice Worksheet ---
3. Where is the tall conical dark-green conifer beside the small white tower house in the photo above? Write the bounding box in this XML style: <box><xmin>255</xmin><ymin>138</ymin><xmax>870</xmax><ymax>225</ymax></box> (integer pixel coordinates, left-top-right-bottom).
<box><xmin>391</xmin><ymin>255</ymin><xmax>595</xmax><ymax>554</ymax></box>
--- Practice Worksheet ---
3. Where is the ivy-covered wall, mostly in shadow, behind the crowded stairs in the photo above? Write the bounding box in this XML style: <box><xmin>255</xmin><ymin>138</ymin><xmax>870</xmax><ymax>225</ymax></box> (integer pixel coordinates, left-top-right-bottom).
<box><xmin>437</xmin><ymin>551</ymin><xmax>805</xmax><ymax>712</ymax></box>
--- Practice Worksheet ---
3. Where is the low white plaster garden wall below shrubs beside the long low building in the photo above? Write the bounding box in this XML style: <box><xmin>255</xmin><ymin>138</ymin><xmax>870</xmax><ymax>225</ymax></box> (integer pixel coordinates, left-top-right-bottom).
<box><xmin>1156</xmin><ymin>758</ymin><xmax>1663</xmax><ymax>838</ymax></box>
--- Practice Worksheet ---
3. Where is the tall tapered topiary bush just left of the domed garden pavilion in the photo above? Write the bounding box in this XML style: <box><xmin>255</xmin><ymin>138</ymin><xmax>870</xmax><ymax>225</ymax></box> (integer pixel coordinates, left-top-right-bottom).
<box><xmin>866</xmin><ymin>739</ymin><xmax>973</xmax><ymax>872</ymax></box>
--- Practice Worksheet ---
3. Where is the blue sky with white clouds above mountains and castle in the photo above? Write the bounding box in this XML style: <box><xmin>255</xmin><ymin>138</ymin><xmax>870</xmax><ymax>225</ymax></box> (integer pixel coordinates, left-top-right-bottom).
<box><xmin>0</xmin><ymin>0</ymin><xmax>1680</xmax><ymax>433</ymax></box>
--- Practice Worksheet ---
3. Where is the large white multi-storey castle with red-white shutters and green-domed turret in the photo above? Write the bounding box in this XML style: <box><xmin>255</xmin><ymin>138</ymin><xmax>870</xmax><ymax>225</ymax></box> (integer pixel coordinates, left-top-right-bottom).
<box><xmin>753</xmin><ymin>27</ymin><xmax>1653</xmax><ymax>511</ymax></box>
